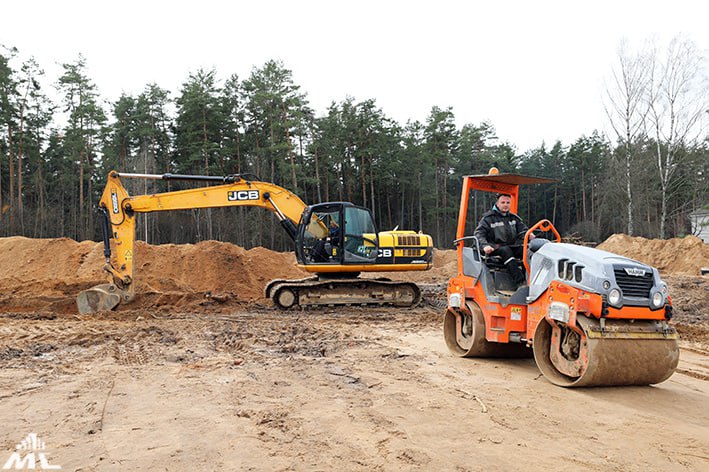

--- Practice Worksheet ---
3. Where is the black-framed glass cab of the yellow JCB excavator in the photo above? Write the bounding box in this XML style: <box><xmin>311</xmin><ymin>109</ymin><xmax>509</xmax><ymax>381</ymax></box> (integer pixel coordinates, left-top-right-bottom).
<box><xmin>296</xmin><ymin>202</ymin><xmax>378</xmax><ymax>266</ymax></box>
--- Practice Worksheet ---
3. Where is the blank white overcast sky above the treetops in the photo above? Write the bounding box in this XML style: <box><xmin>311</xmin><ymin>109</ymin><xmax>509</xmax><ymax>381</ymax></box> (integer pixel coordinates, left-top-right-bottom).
<box><xmin>0</xmin><ymin>0</ymin><xmax>709</xmax><ymax>151</ymax></box>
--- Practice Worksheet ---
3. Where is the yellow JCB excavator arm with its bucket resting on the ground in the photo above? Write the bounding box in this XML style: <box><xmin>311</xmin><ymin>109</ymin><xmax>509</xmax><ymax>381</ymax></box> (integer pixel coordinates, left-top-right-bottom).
<box><xmin>77</xmin><ymin>171</ymin><xmax>310</xmax><ymax>313</ymax></box>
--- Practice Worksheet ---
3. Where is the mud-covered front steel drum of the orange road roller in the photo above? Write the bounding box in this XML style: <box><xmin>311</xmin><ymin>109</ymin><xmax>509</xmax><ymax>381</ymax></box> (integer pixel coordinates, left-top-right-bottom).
<box><xmin>533</xmin><ymin>316</ymin><xmax>679</xmax><ymax>387</ymax></box>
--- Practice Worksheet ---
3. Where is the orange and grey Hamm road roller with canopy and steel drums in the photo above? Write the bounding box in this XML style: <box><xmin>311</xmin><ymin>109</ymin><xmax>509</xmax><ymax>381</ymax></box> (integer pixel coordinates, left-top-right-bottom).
<box><xmin>443</xmin><ymin>171</ymin><xmax>679</xmax><ymax>387</ymax></box>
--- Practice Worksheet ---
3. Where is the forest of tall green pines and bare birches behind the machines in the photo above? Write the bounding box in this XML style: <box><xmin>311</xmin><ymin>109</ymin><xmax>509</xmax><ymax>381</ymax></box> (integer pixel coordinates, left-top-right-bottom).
<box><xmin>0</xmin><ymin>39</ymin><xmax>709</xmax><ymax>250</ymax></box>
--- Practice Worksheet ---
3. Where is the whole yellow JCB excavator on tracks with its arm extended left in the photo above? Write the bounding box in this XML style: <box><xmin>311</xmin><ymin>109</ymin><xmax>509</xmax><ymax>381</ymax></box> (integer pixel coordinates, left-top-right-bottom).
<box><xmin>77</xmin><ymin>171</ymin><xmax>433</xmax><ymax>314</ymax></box>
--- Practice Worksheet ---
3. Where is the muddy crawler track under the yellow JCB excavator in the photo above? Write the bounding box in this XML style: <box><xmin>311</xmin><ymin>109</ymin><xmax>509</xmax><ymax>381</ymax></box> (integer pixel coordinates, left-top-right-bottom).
<box><xmin>266</xmin><ymin>278</ymin><xmax>421</xmax><ymax>310</ymax></box>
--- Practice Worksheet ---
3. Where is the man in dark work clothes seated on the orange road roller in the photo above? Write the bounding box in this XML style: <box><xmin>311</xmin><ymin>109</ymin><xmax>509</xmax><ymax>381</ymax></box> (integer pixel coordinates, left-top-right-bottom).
<box><xmin>475</xmin><ymin>193</ymin><xmax>534</xmax><ymax>285</ymax></box>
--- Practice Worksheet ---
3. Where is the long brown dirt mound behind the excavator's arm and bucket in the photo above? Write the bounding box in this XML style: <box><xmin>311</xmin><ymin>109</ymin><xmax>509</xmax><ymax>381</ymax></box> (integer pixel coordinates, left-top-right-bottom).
<box><xmin>0</xmin><ymin>237</ymin><xmax>305</xmax><ymax>313</ymax></box>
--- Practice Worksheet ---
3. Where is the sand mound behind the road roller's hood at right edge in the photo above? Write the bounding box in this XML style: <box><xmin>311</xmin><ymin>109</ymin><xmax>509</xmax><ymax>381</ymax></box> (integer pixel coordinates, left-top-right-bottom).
<box><xmin>597</xmin><ymin>234</ymin><xmax>709</xmax><ymax>275</ymax></box>
